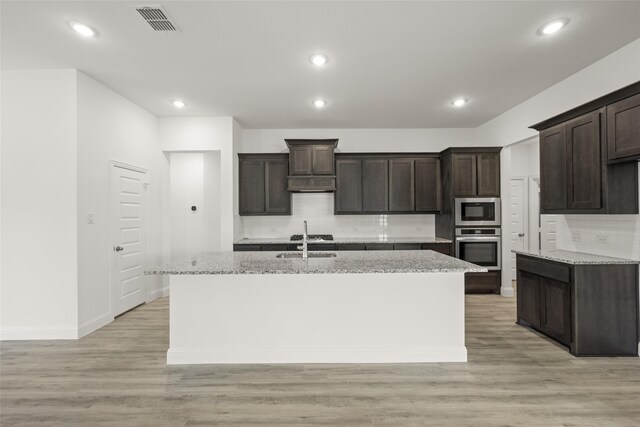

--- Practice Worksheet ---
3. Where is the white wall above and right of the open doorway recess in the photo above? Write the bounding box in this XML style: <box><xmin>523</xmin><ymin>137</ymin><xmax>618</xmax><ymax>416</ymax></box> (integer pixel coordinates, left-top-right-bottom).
<box><xmin>159</xmin><ymin>117</ymin><xmax>237</xmax><ymax>251</ymax></box>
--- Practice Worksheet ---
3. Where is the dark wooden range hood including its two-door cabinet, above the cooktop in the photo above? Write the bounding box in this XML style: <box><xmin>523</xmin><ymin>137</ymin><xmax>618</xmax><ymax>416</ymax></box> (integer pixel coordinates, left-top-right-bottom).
<box><xmin>284</xmin><ymin>139</ymin><xmax>338</xmax><ymax>193</ymax></box>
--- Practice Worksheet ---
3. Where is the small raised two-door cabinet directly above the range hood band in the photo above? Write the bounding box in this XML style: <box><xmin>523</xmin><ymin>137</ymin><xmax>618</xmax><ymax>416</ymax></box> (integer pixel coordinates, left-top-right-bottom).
<box><xmin>285</xmin><ymin>139</ymin><xmax>338</xmax><ymax>175</ymax></box>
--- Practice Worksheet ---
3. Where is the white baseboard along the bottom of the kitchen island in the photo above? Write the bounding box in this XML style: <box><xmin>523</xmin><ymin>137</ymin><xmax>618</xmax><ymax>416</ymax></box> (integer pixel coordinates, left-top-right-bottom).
<box><xmin>167</xmin><ymin>347</ymin><xmax>467</xmax><ymax>365</ymax></box>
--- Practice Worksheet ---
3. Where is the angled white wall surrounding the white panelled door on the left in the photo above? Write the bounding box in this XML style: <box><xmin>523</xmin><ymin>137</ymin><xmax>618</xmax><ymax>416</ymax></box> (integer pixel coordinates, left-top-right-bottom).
<box><xmin>77</xmin><ymin>73</ymin><xmax>166</xmax><ymax>336</ymax></box>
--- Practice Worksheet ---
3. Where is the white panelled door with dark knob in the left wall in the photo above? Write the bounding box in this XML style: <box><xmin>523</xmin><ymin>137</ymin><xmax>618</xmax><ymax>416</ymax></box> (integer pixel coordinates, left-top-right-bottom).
<box><xmin>111</xmin><ymin>165</ymin><xmax>147</xmax><ymax>316</ymax></box>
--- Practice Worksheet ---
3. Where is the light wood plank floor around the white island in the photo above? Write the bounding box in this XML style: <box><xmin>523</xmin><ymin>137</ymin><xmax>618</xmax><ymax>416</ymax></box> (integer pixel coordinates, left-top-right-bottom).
<box><xmin>0</xmin><ymin>295</ymin><xmax>640</xmax><ymax>427</ymax></box>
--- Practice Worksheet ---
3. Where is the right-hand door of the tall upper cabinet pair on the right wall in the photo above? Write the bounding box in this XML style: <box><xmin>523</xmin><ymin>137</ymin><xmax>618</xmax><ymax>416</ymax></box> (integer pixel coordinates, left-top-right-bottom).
<box><xmin>565</xmin><ymin>112</ymin><xmax>602</xmax><ymax>209</ymax></box>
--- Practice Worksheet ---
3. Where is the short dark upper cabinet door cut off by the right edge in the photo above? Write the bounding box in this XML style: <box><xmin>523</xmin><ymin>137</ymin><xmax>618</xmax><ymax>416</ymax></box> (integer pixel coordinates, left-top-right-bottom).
<box><xmin>607</xmin><ymin>94</ymin><xmax>640</xmax><ymax>160</ymax></box>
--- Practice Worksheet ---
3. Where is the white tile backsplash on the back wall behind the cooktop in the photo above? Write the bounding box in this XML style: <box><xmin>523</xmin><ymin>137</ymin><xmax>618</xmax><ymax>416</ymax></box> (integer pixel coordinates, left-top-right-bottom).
<box><xmin>242</xmin><ymin>193</ymin><xmax>435</xmax><ymax>238</ymax></box>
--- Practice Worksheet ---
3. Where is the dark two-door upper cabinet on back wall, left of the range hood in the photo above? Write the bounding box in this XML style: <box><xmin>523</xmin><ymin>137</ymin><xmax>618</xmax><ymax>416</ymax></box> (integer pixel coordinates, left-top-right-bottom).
<box><xmin>238</xmin><ymin>154</ymin><xmax>291</xmax><ymax>215</ymax></box>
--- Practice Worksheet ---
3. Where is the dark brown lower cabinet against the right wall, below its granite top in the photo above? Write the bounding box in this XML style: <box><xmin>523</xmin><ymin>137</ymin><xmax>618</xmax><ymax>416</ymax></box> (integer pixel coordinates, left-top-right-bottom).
<box><xmin>516</xmin><ymin>255</ymin><xmax>640</xmax><ymax>356</ymax></box>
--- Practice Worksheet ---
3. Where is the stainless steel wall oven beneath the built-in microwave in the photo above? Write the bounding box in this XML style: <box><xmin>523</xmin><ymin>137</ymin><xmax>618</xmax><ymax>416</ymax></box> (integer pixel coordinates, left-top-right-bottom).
<box><xmin>455</xmin><ymin>228</ymin><xmax>502</xmax><ymax>270</ymax></box>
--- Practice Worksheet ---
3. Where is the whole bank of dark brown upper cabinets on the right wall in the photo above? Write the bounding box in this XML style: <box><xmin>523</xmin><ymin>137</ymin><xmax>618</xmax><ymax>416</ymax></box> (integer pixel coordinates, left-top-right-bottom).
<box><xmin>531</xmin><ymin>82</ymin><xmax>640</xmax><ymax>214</ymax></box>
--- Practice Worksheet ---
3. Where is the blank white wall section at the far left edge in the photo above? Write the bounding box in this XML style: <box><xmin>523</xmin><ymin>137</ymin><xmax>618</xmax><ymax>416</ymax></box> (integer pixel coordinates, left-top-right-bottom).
<box><xmin>0</xmin><ymin>70</ymin><xmax>78</xmax><ymax>339</ymax></box>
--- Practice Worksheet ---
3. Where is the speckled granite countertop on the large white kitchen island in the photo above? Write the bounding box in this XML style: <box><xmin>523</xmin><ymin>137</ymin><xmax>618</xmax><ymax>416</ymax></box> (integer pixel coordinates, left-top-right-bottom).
<box><xmin>145</xmin><ymin>251</ymin><xmax>487</xmax><ymax>274</ymax></box>
